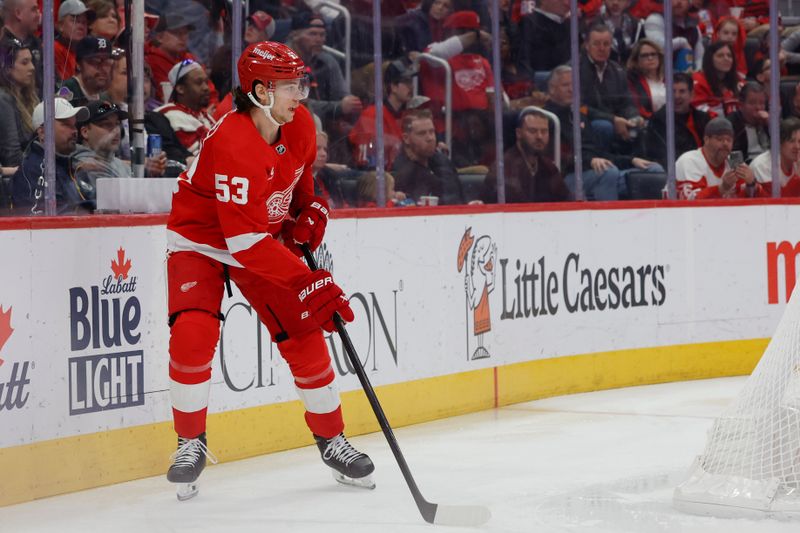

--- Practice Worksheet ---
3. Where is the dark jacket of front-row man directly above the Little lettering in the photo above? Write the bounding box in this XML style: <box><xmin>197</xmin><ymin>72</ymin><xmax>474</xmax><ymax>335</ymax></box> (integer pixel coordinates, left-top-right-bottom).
<box><xmin>482</xmin><ymin>146</ymin><xmax>570</xmax><ymax>204</ymax></box>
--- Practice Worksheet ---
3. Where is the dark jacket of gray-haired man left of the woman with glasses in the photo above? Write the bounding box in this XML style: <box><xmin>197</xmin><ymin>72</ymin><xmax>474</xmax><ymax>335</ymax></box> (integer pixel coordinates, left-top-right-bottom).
<box><xmin>580</xmin><ymin>54</ymin><xmax>639</xmax><ymax>122</ymax></box>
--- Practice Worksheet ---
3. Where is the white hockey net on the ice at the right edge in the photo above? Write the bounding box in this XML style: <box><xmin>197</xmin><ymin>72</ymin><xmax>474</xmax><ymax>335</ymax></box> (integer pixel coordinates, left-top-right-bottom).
<box><xmin>674</xmin><ymin>290</ymin><xmax>800</xmax><ymax>518</ymax></box>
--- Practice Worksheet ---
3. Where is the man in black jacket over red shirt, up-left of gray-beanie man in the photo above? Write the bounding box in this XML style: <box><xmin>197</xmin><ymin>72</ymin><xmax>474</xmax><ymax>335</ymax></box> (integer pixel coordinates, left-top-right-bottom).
<box><xmin>643</xmin><ymin>72</ymin><xmax>711</xmax><ymax>166</ymax></box>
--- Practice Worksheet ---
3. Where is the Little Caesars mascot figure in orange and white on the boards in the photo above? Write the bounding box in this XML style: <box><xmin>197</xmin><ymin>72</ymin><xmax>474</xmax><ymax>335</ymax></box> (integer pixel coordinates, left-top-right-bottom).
<box><xmin>458</xmin><ymin>227</ymin><xmax>497</xmax><ymax>360</ymax></box>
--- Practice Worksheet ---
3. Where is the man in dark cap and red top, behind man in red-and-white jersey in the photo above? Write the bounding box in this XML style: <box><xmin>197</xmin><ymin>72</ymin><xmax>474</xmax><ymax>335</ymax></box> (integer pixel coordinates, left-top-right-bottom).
<box><xmin>144</xmin><ymin>13</ymin><xmax>217</xmax><ymax>103</ymax></box>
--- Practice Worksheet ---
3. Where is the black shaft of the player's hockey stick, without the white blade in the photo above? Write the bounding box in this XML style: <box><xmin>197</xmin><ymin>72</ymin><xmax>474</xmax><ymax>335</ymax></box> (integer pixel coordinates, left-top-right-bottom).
<box><xmin>300</xmin><ymin>244</ymin><xmax>437</xmax><ymax>523</ymax></box>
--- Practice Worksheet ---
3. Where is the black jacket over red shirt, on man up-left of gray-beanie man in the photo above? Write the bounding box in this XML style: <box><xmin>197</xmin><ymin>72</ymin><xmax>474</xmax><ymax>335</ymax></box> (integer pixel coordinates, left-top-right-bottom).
<box><xmin>642</xmin><ymin>106</ymin><xmax>711</xmax><ymax>168</ymax></box>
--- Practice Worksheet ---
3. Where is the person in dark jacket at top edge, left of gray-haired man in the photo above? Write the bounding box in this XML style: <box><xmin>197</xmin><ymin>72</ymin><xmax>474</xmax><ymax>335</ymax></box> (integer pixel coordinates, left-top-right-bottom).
<box><xmin>519</xmin><ymin>0</ymin><xmax>570</xmax><ymax>79</ymax></box>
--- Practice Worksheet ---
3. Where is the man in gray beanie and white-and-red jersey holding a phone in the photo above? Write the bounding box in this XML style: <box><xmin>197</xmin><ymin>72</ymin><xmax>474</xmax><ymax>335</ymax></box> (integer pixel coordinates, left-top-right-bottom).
<box><xmin>675</xmin><ymin>117</ymin><xmax>762</xmax><ymax>200</ymax></box>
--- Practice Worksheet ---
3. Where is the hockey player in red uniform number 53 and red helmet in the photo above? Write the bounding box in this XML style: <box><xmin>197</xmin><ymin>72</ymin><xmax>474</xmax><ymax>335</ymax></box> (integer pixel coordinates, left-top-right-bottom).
<box><xmin>167</xmin><ymin>41</ymin><xmax>374</xmax><ymax>500</ymax></box>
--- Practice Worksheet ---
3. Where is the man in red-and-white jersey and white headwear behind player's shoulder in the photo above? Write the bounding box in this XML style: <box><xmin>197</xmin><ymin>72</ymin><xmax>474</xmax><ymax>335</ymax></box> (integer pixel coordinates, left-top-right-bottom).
<box><xmin>156</xmin><ymin>59</ymin><xmax>214</xmax><ymax>156</ymax></box>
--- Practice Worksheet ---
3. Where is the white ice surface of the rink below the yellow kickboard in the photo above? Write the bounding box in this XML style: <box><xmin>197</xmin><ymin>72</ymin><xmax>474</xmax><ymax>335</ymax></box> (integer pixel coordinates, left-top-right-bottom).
<box><xmin>0</xmin><ymin>378</ymin><xmax>800</xmax><ymax>533</ymax></box>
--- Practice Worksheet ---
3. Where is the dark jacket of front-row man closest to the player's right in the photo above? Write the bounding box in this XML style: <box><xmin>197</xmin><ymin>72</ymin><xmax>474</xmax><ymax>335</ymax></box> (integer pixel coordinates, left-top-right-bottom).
<box><xmin>392</xmin><ymin>149</ymin><xmax>464</xmax><ymax>205</ymax></box>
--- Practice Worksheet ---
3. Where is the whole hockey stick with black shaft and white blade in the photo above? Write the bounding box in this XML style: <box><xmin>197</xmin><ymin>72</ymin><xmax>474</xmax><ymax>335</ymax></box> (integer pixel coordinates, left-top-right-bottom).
<box><xmin>300</xmin><ymin>244</ymin><xmax>492</xmax><ymax>527</ymax></box>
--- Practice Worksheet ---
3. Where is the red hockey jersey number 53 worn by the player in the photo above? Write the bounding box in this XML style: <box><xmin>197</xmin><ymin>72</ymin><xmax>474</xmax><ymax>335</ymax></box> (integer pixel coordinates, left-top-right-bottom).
<box><xmin>167</xmin><ymin>106</ymin><xmax>316</xmax><ymax>288</ymax></box>
